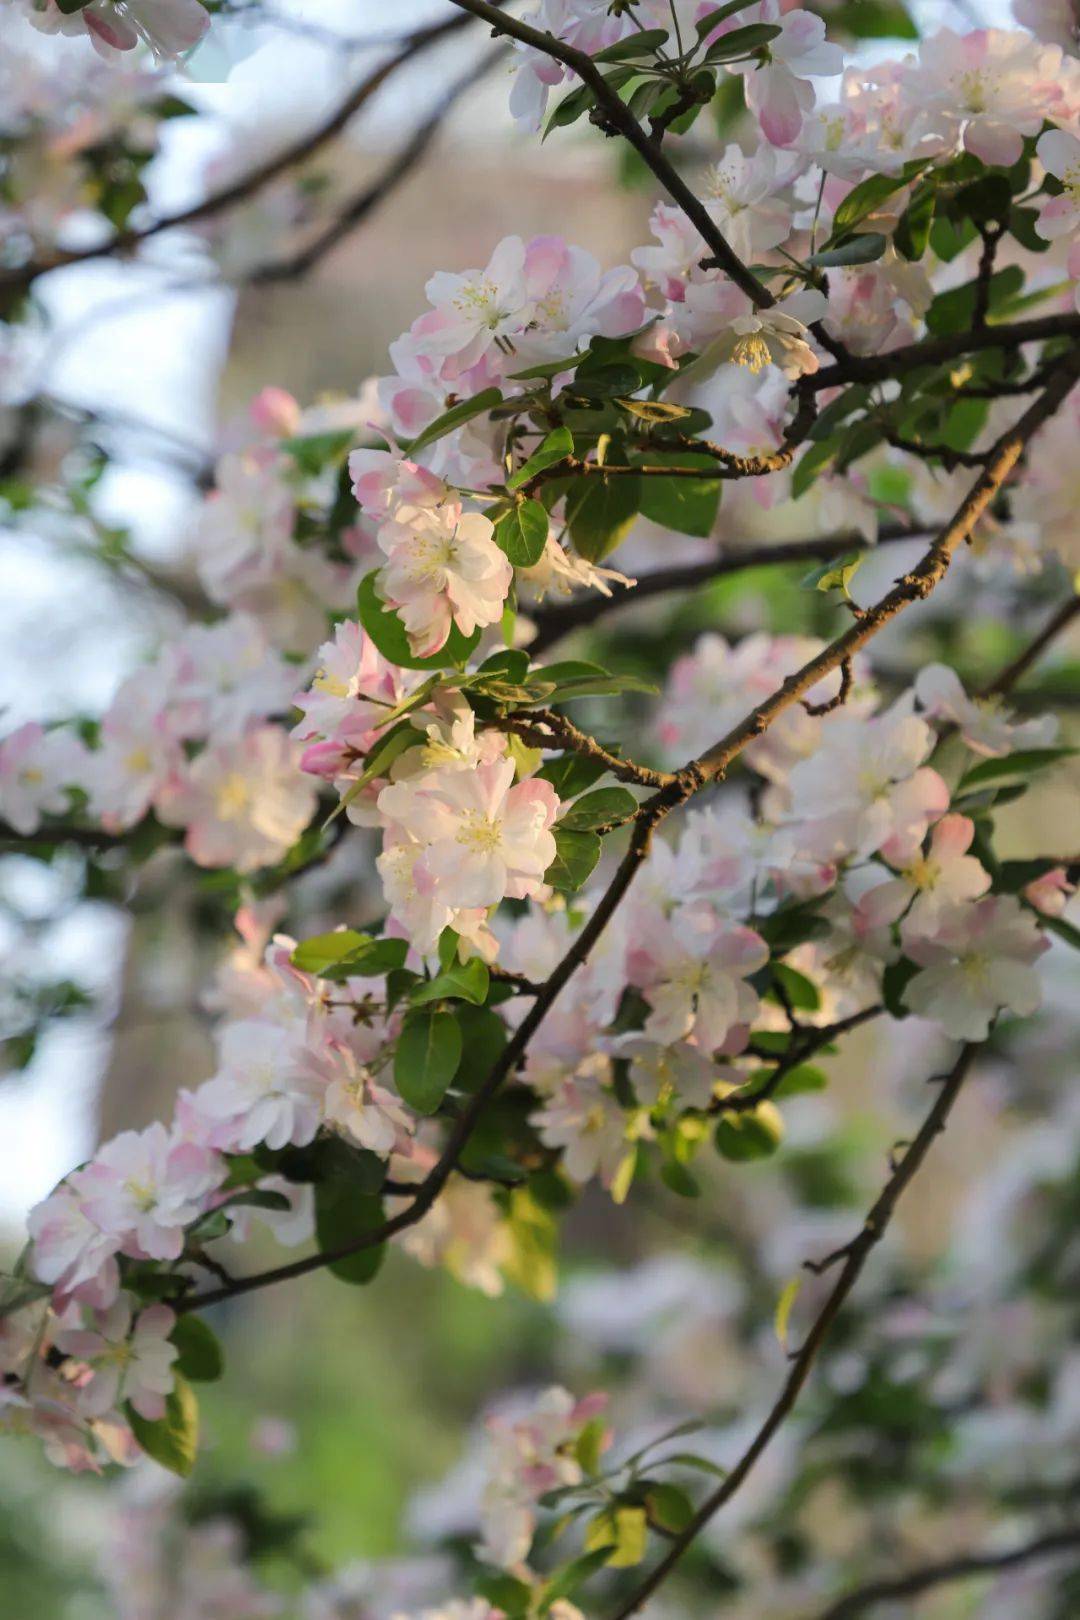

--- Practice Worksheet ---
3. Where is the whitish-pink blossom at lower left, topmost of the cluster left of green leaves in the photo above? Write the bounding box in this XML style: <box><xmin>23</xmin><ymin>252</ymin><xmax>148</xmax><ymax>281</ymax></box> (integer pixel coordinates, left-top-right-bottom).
<box><xmin>193</xmin><ymin>1019</ymin><xmax>324</xmax><ymax>1153</ymax></box>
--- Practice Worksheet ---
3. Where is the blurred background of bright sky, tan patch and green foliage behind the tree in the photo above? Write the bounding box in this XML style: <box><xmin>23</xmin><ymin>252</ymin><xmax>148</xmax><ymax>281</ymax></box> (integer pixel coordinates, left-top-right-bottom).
<box><xmin>0</xmin><ymin>0</ymin><xmax>1075</xmax><ymax>1620</ymax></box>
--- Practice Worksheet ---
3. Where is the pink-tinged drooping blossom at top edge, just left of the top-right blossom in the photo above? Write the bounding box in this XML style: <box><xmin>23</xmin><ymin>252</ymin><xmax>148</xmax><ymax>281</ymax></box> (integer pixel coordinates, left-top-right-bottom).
<box><xmin>729</xmin><ymin>0</ymin><xmax>844</xmax><ymax>146</ymax></box>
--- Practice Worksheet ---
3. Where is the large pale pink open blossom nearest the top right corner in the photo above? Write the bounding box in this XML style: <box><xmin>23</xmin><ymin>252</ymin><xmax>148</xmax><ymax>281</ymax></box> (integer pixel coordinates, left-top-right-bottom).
<box><xmin>907</xmin><ymin>28</ymin><xmax>1065</xmax><ymax>167</ymax></box>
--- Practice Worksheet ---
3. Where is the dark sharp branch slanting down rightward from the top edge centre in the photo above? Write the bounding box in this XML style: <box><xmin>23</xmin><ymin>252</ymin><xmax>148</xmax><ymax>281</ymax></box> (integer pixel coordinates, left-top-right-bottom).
<box><xmin>450</xmin><ymin>0</ymin><xmax>776</xmax><ymax>309</ymax></box>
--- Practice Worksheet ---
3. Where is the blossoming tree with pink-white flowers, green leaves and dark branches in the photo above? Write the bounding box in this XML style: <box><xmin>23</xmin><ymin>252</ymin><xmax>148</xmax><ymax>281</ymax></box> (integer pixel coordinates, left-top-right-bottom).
<box><xmin>0</xmin><ymin>0</ymin><xmax>1080</xmax><ymax>1620</ymax></box>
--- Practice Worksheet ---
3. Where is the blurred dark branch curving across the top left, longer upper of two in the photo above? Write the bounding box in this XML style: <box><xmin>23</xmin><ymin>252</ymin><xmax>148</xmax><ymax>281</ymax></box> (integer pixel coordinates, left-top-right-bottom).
<box><xmin>0</xmin><ymin>16</ymin><xmax>468</xmax><ymax>293</ymax></box>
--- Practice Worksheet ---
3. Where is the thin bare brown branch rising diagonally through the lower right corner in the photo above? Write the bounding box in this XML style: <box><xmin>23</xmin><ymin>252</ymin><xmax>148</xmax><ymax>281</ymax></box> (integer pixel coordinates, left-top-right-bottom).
<box><xmin>612</xmin><ymin>1047</ymin><xmax>975</xmax><ymax>1620</ymax></box>
